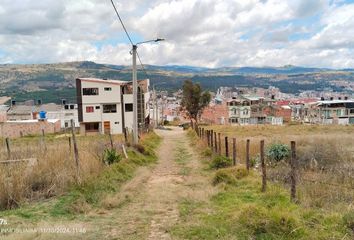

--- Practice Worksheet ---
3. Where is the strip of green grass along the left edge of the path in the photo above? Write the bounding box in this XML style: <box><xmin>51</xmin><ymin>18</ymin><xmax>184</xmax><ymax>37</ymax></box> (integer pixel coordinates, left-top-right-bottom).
<box><xmin>1</xmin><ymin>133</ymin><xmax>161</xmax><ymax>221</ymax></box>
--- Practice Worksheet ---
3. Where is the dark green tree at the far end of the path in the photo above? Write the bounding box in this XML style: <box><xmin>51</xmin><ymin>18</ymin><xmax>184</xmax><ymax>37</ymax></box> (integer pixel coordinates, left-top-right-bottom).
<box><xmin>181</xmin><ymin>80</ymin><xmax>211</xmax><ymax>122</ymax></box>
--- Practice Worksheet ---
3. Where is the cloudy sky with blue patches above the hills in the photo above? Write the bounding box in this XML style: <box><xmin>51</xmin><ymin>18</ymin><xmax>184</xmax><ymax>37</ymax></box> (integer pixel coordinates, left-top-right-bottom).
<box><xmin>0</xmin><ymin>0</ymin><xmax>354</xmax><ymax>68</ymax></box>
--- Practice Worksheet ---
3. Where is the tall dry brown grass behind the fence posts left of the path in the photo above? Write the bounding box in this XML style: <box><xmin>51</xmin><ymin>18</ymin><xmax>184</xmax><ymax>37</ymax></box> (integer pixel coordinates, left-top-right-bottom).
<box><xmin>0</xmin><ymin>135</ymin><xmax>121</xmax><ymax>210</ymax></box>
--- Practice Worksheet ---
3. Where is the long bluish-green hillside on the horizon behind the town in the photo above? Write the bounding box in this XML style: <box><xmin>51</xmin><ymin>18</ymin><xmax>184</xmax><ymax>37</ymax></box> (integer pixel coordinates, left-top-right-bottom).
<box><xmin>0</xmin><ymin>61</ymin><xmax>354</xmax><ymax>102</ymax></box>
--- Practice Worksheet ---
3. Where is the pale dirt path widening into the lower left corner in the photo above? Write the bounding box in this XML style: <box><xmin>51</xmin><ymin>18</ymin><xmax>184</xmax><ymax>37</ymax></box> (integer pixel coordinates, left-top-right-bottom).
<box><xmin>1</xmin><ymin>128</ymin><xmax>213</xmax><ymax>240</ymax></box>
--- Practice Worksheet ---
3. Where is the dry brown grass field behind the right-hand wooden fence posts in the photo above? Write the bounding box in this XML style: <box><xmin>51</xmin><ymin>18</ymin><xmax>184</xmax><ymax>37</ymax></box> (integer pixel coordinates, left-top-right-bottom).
<box><xmin>206</xmin><ymin>125</ymin><xmax>354</xmax><ymax>212</ymax></box>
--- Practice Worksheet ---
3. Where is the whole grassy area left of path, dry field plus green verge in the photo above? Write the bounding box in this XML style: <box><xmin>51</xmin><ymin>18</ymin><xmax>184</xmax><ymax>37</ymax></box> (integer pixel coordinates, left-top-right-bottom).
<box><xmin>0</xmin><ymin>133</ymin><xmax>160</xmax><ymax>216</ymax></box>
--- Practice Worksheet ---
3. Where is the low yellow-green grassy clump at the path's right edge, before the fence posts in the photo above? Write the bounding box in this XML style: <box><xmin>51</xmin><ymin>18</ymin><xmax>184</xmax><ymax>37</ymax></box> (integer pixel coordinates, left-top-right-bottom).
<box><xmin>213</xmin><ymin>167</ymin><xmax>248</xmax><ymax>185</ymax></box>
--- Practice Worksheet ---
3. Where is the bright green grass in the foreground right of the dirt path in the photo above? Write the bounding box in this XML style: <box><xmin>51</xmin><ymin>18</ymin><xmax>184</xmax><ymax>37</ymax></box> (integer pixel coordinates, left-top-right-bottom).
<box><xmin>171</xmin><ymin>129</ymin><xmax>354</xmax><ymax>240</ymax></box>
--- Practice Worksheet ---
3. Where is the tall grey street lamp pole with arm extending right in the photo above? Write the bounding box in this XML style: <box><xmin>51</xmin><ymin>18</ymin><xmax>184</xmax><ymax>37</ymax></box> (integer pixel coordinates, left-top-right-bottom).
<box><xmin>132</xmin><ymin>38</ymin><xmax>165</xmax><ymax>144</ymax></box>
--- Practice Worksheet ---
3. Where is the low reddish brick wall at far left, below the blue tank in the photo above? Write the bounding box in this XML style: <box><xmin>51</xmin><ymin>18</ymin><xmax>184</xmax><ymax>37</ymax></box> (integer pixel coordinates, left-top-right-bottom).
<box><xmin>0</xmin><ymin>120</ymin><xmax>60</xmax><ymax>138</ymax></box>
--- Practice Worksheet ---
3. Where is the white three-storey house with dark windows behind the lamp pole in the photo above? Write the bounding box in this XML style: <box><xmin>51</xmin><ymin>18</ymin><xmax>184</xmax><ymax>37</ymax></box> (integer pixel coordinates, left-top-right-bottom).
<box><xmin>76</xmin><ymin>78</ymin><xmax>150</xmax><ymax>134</ymax></box>
